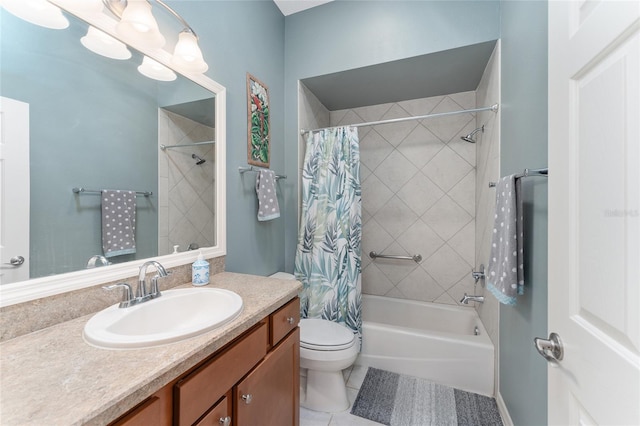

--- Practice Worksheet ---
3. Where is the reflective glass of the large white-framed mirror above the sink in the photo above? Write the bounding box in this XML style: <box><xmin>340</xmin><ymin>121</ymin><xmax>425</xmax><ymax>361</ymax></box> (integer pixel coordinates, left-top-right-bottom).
<box><xmin>0</xmin><ymin>6</ymin><xmax>216</xmax><ymax>284</ymax></box>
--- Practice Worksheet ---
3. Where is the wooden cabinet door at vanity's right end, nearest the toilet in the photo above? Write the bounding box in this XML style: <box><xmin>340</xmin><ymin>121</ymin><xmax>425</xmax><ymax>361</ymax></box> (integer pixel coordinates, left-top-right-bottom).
<box><xmin>234</xmin><ymin>328</ymin><xmax>300</xmax><ymax>426</ymax></box>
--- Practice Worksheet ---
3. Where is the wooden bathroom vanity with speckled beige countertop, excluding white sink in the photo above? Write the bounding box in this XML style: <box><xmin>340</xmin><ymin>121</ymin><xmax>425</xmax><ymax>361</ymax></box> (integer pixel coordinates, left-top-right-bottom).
<box><xmin>0</xmin><ymin>273</ymin><xmax>300</xmax><ymax>426</ymax></box>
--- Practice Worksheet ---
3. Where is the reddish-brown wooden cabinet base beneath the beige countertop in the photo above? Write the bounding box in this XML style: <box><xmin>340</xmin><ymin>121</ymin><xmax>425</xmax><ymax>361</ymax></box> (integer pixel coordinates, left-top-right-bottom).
<box><xmin>112</xmin><ymin>298</ymin><xmax>300</xmax><ymax>426</ymax></box>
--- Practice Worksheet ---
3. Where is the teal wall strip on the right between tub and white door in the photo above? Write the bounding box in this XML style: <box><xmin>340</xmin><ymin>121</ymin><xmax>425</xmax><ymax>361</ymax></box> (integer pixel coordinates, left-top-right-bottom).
<box><xmin>500</xmin><ymin>0</ymin><xmax>553</xmax><ymax>425</ymax></box>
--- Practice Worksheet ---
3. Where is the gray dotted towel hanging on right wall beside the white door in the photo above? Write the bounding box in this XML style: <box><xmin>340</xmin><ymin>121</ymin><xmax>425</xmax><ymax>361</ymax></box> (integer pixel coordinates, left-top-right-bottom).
<box><xmin>487</xmin><ymin>175</ymin><xmax>524</xmax><ymax>305</ymax></box>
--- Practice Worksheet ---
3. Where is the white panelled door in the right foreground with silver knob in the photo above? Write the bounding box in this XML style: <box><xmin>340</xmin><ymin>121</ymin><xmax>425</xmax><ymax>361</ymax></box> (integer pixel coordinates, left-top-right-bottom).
<box><xmin>548</xmin><ymin>0</ymin><xmax>640</xmax><ymax>425</ymax></box>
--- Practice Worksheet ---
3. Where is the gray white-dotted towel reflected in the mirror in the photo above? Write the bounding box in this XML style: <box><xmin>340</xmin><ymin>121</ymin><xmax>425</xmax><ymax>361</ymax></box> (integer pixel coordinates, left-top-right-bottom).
<box><xmin>101</xmin><ymin>189</ymin><xmax>136</xmax><ymax>257</ymax></box>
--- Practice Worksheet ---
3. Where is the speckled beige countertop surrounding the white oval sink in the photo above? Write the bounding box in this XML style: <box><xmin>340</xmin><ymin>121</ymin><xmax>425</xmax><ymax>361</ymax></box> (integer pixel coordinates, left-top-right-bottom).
<box><xmin>0</xmin><ymin>272</ymin><xmax>301</xmax><ymax>425</ymax></box>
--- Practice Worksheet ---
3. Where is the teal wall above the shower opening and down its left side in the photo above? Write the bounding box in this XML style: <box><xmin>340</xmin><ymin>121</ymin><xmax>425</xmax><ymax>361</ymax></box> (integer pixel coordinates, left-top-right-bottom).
<box><xmin>284</xmin><ymin>1</ymin><xmax>500</xmax><ymax>272</ymax></box>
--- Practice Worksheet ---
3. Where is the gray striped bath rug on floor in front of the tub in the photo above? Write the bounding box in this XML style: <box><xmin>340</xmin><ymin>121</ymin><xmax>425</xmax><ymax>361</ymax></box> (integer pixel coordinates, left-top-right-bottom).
<box><xmin>351</xmin><ymin>367</ymin><xmax>502</xmax><ymax>426</ymax></box>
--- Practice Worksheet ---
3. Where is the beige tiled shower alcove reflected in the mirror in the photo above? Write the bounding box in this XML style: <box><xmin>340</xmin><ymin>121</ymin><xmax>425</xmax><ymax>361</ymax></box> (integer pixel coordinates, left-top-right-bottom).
<box><xmin>158</xmin><ymin>109</ymin><xmax>215</xmax><ymax>255</ymax></box>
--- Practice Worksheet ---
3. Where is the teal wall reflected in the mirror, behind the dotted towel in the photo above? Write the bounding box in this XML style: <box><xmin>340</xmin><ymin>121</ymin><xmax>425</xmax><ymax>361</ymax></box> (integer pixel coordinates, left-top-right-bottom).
<box><xmin>0</xmin><ymin>10</ymin><xmax>159</xmax><ymax>278</ymax></box>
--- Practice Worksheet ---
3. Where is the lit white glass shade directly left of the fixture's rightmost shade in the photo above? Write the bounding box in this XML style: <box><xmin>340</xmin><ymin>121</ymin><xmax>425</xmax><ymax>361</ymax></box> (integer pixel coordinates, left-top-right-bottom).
<box><xmin>116</xmin><ymin>0</ymin><xmax>165</xmax><ymax>48</ymax></box>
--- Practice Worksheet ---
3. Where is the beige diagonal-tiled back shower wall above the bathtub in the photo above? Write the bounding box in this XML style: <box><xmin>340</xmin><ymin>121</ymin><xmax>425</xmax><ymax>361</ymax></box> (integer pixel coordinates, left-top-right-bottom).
<box><xmin>299</xmin><ymin>85</ymin><xmax>476</xmax><ymax>307</ymax></box>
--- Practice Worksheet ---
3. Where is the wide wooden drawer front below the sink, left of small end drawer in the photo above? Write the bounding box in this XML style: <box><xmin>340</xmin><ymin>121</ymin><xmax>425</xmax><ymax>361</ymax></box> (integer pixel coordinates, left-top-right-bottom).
<box><xmin>174</xmin><ymin>322</ymin><xmax>269</xmax><ymax>425</ymax></box>
